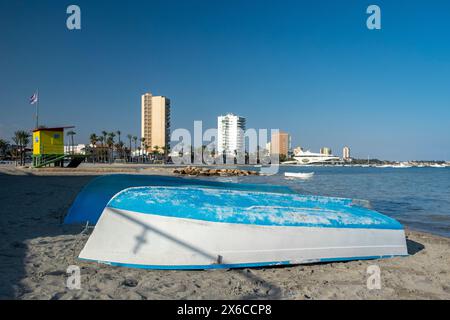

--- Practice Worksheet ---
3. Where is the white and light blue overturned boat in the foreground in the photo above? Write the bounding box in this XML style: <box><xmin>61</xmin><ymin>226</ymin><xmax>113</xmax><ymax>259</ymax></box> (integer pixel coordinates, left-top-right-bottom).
<box><xmin>79</xmin><ymin>186</ymin><xmax>407</xmax><ymax>269</ymax></box>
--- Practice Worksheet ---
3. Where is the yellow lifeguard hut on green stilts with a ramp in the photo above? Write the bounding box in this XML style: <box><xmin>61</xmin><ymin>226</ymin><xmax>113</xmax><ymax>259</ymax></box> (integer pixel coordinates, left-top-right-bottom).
<box><xmin>33</xmin><ymin>127</ymin><xmax>84</xmax><ymax>168</ymax></box>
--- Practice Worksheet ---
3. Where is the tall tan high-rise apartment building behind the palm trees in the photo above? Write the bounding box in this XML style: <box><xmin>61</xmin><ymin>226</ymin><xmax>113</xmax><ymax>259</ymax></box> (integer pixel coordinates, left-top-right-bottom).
<box><xmin>141</xmin><ymin>93</ymin><xmax>170</xmax><ymax>153</ymax></box>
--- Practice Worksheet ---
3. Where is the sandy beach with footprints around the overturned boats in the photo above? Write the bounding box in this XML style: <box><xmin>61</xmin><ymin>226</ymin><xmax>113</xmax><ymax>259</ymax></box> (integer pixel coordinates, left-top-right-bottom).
<box><xmin>0</xmin><ymin>166</ymin><xmax>450</xmax><ymax>299</ymax></box>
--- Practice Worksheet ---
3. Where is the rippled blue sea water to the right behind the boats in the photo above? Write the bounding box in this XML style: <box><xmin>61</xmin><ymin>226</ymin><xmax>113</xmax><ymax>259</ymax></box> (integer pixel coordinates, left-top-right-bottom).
<box><xmin>236</xmin><ymin>166</ymin><xmax>450</xmax><ymax>237</ymax></box>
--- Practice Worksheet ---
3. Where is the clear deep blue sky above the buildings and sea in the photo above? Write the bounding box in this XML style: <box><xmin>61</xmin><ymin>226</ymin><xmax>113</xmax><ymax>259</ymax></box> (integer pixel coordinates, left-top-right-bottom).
<box><xmin>0</xmin><ymin>0</ymin><xmax>450</xmax><ymax>160</ymax></box>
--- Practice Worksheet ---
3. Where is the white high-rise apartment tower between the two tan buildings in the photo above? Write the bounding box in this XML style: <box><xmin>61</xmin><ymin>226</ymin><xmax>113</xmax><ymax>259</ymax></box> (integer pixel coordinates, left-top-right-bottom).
<box><xmin>217</xmin><ymin>113</ymin><xmax>245</xmax><ymax>156</ymax></box>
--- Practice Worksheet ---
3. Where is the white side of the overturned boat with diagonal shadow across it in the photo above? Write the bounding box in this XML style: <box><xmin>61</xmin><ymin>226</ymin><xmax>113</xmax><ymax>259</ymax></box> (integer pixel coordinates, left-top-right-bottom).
<box><xmin>79</xmin><ymin>207</ymin><xmax>407</xmax><ymax>269</ymax></box>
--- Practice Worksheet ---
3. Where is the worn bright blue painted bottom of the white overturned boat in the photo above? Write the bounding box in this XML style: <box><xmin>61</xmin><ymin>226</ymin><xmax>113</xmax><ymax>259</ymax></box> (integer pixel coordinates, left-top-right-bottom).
<box><xmin>108</xmin><ymin>187</ymin><xmax>403</xmax><ymax>230</ymax></box>
